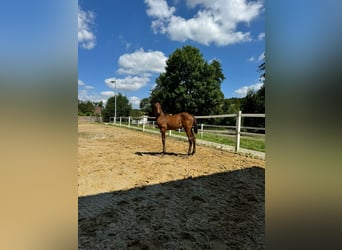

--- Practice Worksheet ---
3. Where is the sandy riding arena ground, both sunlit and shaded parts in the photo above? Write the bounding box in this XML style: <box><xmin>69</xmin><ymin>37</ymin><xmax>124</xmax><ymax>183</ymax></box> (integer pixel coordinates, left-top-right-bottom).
<box><xmin>78</xmin><ymin>123</ymin><xmax>265</xmax><ymax>249</ymax></box>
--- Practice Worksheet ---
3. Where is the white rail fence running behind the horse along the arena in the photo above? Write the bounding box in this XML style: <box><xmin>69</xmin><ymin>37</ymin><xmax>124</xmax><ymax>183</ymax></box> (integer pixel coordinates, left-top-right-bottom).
<box><xmin>110</xmin><ymin>111</ymin><xmax>265</xmax><ymax>152</ymax></box>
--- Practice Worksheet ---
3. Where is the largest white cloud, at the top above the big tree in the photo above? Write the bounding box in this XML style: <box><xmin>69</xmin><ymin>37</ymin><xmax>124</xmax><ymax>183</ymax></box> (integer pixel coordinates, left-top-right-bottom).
<box><xmin>145</xmin><ymin>0</ymin><xmax>263</xmax><ymax>46</ymax></box>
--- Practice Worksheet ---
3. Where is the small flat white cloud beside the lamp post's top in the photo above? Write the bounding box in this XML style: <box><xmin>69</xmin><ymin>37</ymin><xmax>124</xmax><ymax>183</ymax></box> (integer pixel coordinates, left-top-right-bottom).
<box><xmin>105</xmin><ymin>76</ymin><xmax>149</xmax><ymax>91</ymax></box>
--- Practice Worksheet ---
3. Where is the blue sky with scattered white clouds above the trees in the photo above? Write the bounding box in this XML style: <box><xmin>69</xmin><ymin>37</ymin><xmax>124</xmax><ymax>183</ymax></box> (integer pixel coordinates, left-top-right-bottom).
<box><xmin>78</xmin><ymin>0</ymin><xmax>265</xmax><ymax>108</ymax></box>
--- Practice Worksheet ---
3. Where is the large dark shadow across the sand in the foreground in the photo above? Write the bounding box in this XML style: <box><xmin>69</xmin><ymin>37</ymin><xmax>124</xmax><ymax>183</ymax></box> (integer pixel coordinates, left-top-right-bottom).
<box><xmin>78</xmin><ymin>166</ymin><xmax>265</xmax><ymax>249</ymax></box>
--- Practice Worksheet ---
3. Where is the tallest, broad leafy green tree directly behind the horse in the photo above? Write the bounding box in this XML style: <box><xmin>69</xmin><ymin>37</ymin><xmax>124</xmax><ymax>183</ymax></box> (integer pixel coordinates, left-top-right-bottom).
<box><xmin>151</xmin><ymin>46</ymin><xmax>225</xmax><ymax>115</ymax></box>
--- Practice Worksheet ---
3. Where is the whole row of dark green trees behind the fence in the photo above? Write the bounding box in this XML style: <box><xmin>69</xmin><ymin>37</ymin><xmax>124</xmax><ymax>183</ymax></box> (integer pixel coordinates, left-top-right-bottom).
<box><xmin>78</xmin><ymin>46</ymin><xmax>266</xmax><ymax>127</ymax></box>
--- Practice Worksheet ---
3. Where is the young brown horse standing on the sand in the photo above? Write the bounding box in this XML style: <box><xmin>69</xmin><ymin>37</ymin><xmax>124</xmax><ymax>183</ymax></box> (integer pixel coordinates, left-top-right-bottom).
<box><xmin>154</xmin><ymin>102</ymin><xmax>198</xmax><ymax>155</ymax></box>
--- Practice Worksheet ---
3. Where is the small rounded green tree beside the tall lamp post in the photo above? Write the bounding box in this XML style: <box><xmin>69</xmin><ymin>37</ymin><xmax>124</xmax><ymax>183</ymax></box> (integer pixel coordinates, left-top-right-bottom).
<box><xmin>103</xmin><ymin>93</ymin><xmax>132</xmax><ymax>122</ymax></box>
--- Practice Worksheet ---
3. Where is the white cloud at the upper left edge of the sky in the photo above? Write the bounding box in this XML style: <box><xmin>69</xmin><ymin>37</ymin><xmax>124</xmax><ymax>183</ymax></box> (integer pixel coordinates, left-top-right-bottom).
<box><xmin>78</xmin><ymin>6</ymin><xmax>96</xmax><ymax>49</ymax></box>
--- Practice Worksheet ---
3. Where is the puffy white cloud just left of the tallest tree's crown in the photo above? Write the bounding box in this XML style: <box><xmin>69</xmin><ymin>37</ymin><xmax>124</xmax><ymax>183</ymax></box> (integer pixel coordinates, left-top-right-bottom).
<box><xmin>118</xmin><ymin>49</ymin><xmax>167</xmax><ymax>75</ymax></box>
